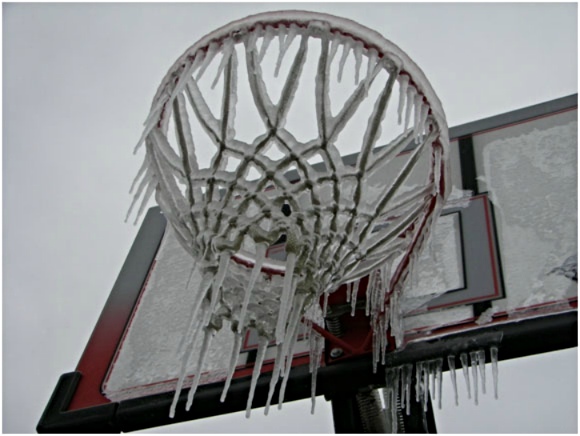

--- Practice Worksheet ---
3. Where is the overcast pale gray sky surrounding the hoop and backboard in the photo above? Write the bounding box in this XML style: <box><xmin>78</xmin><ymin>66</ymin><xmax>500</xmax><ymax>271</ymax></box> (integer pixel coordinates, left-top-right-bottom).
<box><xmin>2</xmin><ymin>3</ymin><xmax>578</xmax><ymax>433</ymax></box>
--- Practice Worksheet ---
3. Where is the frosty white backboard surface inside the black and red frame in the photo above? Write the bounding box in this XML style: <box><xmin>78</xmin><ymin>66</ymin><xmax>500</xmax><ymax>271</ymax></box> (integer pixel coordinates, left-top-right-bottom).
<box><xmin>102</xmin><ymin>97</ymin><xmax>577</xmax><ymax>401</ymax></box>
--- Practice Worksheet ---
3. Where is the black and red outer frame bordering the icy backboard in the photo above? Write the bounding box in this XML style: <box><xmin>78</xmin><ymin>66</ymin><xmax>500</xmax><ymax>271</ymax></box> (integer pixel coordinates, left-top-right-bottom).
<box><xmin>37</xmin><ymin>95</ymin><xmax>578</xmax><ymax>433</ymax></box>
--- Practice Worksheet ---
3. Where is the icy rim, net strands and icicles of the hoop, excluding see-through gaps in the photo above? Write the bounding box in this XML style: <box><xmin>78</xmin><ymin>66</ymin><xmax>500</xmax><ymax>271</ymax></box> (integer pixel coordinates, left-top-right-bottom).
<box><xmin>129</xmin><ymin>12</ymin><xmax>449</xmax><ymax>416</ymax></box>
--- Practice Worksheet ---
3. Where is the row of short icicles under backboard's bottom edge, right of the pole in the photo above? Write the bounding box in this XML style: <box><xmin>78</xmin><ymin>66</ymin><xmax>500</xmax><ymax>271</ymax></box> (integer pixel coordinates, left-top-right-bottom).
<box><xmin>383</xmin><ymin>346</ymin><xmax>498</xmax><ymax>433</ymax></box>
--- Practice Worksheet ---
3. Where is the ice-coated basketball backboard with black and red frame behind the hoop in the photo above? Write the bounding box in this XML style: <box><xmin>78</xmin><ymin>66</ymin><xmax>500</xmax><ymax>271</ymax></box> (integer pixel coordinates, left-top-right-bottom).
<box><xmin>38</xmin><ymin>95</ymin><xmax>578</xmax><ymax>432</ymax></box>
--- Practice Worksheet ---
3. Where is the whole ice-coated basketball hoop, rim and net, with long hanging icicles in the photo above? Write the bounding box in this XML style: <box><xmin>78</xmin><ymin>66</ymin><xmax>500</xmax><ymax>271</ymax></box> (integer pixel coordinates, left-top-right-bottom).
<box><xmin>130</xmin><ymin>11</ymin><xmax>449</xmax><ymax>415</ymax></box>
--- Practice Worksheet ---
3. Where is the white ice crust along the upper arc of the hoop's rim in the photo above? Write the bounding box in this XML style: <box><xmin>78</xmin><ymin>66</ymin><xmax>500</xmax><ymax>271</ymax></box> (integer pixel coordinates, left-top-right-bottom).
<box><xmin>151</xmin><ymin>10</ymin><xmax>448</xmax><ymax>141</ymax></box>
